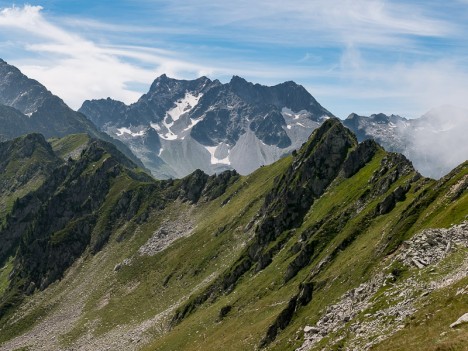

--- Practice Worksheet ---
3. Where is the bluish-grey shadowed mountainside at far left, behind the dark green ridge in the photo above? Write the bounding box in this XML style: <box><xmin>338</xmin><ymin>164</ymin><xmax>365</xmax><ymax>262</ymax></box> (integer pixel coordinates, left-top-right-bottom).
<box><xmin>0</xmin><ymin>59</ymin><xmax>143</xmax><ymax>167</ymax></box>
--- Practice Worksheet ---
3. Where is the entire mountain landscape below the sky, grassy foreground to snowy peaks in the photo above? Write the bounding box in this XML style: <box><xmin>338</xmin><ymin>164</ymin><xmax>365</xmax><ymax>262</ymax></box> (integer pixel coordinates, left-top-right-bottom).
<box><xmin>0</xmin><ymin>61</ymin><xmax>468</xmax><ymax>351</ymax></box>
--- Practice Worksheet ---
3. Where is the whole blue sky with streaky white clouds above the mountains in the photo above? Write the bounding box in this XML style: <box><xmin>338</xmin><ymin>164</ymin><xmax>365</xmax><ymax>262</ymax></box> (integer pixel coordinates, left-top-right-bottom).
<box><xmin>0</xmin><ymin>0</ymin><xmax>468</xmax><ymax>118</ymax></box>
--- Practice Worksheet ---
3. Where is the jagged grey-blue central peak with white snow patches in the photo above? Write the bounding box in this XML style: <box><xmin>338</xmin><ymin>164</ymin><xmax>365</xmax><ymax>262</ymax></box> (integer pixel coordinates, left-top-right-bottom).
<box><xmin>79</xmin><ymin>75</ymin><xmax>333</xmax><ymax>178</ymax></box>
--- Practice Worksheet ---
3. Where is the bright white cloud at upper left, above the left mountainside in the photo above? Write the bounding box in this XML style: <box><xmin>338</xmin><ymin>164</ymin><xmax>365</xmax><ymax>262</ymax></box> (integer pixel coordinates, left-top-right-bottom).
<box><xmin>0</xmin><ymin>5</ymin><xmax>212</xmax><ymax>108</ymax></box>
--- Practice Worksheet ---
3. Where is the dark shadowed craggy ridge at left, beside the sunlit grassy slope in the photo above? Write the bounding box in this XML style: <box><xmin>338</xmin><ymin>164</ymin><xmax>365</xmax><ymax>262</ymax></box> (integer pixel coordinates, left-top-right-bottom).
<box><xmin>0</xmin><ymin>134</ymin><xmax>151</xmax><ymax>314</ymax></box>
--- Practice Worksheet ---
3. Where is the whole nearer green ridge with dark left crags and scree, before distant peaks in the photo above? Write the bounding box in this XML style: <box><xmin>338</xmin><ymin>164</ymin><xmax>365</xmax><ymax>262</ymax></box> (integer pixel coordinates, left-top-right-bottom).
<box><xmin>0</xmin><ymin>118</ymin><xmax>468</xmax><ymax>351</ymax></box>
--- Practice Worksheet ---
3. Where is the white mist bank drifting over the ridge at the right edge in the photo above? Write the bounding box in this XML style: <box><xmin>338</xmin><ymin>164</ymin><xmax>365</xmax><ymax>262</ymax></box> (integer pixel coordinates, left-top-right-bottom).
<box><xmin>397</xmin><ymin>105</ymin><xmax>468</xmax><ymax>179</ymax></box>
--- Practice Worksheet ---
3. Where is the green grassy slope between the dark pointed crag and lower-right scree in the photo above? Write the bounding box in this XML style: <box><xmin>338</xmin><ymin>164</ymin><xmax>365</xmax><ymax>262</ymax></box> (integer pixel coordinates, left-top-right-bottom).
<box><xmin>145</xmin><ymin>122</ymin><xmax>467</xmax><ymax>350</ymax></box>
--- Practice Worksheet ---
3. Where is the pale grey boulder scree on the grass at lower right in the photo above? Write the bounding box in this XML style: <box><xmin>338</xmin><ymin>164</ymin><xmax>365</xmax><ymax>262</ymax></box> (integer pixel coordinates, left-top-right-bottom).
<box><xmin>296</xmin><ymin>221</ymin><xmax>468</xmax><ymax>351</ymax></box>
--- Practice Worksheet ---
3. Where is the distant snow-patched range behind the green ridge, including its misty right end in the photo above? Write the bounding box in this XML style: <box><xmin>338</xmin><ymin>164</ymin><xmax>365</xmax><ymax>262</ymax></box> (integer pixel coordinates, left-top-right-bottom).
<box><xmin>79</xmin><ymin>75</ymin><xmax>468</xmax><ymax>178</ymax></box>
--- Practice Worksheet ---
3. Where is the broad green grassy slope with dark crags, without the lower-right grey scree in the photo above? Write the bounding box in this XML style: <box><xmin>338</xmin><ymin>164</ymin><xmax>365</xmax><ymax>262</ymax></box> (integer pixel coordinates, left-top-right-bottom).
<box><xmin>0</xmin><ymin>120</ymin><xmax>468</xmax><ymax>350</ymax></box>
